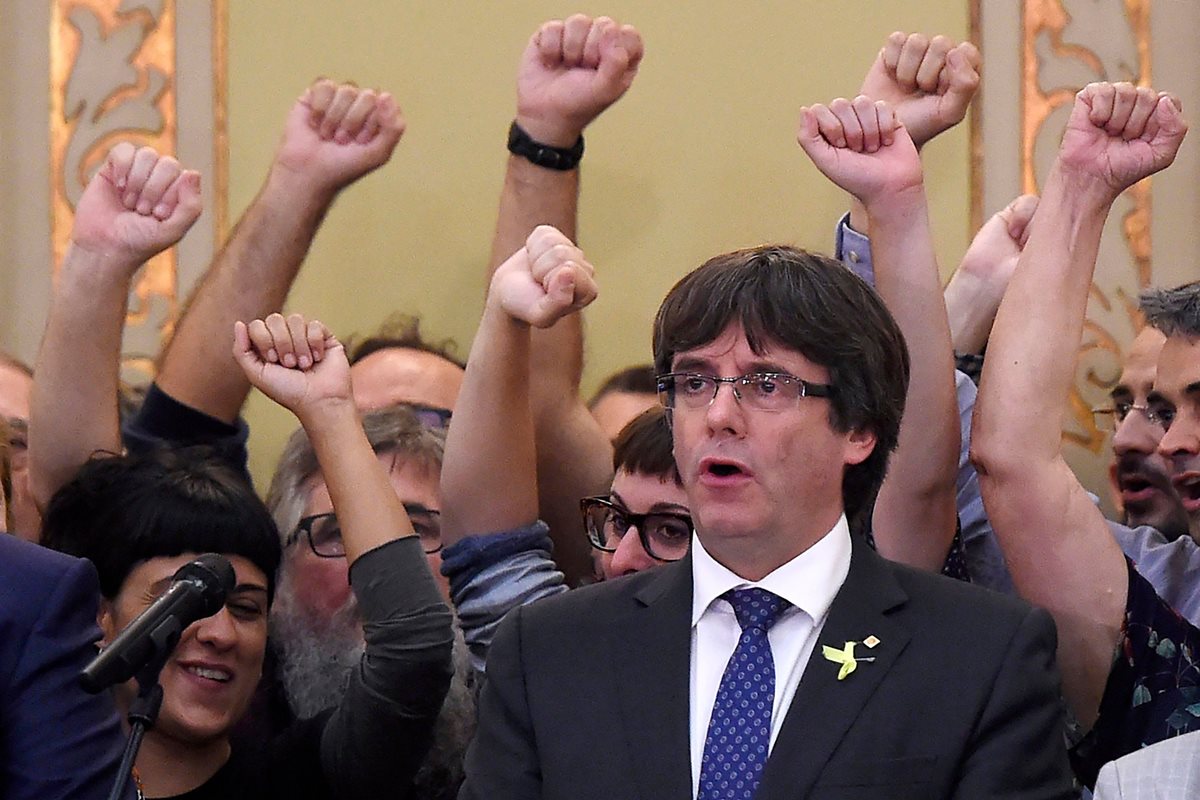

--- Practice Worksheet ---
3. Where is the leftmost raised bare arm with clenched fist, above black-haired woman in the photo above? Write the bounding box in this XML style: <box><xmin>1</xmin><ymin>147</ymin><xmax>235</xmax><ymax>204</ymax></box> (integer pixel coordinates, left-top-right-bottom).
<box><xmin>29</xmin><ymin>143</ymin><xmax>200</xmax><ymax>506</ymax></box>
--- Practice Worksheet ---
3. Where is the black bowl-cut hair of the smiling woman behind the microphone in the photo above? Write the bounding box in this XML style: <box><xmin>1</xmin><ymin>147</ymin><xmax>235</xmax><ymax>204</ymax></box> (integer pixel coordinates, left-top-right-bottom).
<box><xmin>42</xmin><ymin>447</ymin><xmax>281</xmax><ymax>601</ymax></box>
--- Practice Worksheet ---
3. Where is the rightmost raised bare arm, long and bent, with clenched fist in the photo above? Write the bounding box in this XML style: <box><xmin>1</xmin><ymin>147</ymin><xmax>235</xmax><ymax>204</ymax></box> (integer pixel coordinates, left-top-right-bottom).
<box><xmin>971</xmin><ymin>84</ymin><xmax>1187</xmax><ymax>726</ymax></box>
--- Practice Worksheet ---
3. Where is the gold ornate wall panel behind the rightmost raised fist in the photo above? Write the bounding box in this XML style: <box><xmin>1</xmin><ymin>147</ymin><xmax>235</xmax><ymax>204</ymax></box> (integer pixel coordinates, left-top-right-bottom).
<box><xmin>971</xmin><ymin>0</ymin><xmax>1200</xmax><ymax>513</ymax></box>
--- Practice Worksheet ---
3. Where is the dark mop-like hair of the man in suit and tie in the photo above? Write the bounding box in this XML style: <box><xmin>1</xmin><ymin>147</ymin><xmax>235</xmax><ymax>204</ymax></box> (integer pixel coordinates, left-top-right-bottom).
<box><xmin>654</xmin><ymin>245</ymin><xmax>910</xmax><ymax>523</ymax></box>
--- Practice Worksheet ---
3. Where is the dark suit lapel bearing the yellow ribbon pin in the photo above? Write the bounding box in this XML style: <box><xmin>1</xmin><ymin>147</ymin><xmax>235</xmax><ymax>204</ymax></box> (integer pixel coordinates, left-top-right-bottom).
<box><xmin>756</xmin><ymin>536</ymin><xmax>910</xmax><ymax>800</ymax></box>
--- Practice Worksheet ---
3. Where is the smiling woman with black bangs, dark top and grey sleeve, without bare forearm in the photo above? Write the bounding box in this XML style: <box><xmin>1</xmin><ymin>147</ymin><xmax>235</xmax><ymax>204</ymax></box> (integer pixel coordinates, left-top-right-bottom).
<box><xmin>36</xmin><ymin>441</ymin><xmax>450</xmax><ymax>800</ymax></box>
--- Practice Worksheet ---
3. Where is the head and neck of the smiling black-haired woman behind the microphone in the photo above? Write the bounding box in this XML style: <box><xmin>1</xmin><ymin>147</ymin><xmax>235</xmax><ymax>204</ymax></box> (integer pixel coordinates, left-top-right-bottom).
<box><xmin>43</xmin><ymin>451</ymin><xmax>280</xmax><ymax>796</ymax></box>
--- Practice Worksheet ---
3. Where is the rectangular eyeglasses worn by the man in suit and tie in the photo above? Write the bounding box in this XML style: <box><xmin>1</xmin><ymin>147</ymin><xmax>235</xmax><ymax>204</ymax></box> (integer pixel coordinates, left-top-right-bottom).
<box><xmin>658</xmin><ymin>372</ymin><xmax>833</xmax><ymax>411</ymax></box>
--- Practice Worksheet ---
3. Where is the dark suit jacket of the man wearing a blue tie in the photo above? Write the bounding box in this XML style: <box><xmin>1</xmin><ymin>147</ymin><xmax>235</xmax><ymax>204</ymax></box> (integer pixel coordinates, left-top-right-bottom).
<box><xmin>460</xmin><ymin>539</ymin><xmax>1074</xmax><ymax>800</ymax></box>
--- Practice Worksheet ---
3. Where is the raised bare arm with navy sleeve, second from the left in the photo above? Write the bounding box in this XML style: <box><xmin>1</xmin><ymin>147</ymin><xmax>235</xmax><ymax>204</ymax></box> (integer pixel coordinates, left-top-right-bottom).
<box><xmin>157</xmin><ymin>79</ymin><xmax>404</xmax><ymax>422</ymax></box>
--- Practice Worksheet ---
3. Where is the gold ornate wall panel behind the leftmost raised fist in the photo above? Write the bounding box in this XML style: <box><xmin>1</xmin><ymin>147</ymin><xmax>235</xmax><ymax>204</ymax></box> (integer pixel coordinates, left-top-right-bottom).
<box><xmin>49</xmin><ymin>0</ymin><xmax>227</xmax><ymax>375</ymax></box>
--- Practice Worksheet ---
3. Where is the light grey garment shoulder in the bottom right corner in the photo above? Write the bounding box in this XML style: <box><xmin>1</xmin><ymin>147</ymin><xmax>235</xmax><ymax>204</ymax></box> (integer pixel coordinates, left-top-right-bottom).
<box><xmin>1092</xmin><ymin>730</ymin><xmax>1200</xmax><ymax>800</ymax></box>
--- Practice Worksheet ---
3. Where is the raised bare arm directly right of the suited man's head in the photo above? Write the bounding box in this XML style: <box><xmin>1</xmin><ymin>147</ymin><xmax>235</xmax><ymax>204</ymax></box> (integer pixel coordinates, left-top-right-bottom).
<box><xmin>799</xmin><ymin>95</ymin><xmax>960</xmax><ymax>571</ymax></box>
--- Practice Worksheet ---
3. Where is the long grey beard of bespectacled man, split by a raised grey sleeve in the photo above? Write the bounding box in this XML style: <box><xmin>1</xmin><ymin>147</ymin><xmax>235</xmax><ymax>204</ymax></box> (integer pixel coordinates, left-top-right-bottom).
<box><xmin>271</xmin><ymin>587</ymin><xmax>476</xmax><ymax>800</ymax></box>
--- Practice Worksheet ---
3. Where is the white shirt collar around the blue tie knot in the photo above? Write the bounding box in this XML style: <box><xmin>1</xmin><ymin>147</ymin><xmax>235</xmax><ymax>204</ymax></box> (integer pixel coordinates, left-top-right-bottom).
<box><xmin>691</xmin><ymin>515</ymin><xmax>851</xmax><ymax>627</ymax></box>
